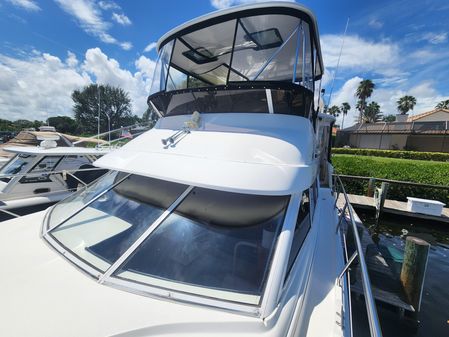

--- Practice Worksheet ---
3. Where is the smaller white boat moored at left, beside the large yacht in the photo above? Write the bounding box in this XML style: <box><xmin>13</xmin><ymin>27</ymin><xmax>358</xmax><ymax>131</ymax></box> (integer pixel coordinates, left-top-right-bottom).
<box><xmin>0</xmin><ymin>141</ymin><xmax>109</xmax><ymax>221</ymax></box>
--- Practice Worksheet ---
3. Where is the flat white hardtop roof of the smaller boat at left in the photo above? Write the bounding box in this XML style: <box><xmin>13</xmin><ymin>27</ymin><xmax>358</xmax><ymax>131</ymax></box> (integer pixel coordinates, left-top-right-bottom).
<box><xmin>3</xmin><ymin>146</ymin><xmax>109</xmax><ymax>156</ymax></box>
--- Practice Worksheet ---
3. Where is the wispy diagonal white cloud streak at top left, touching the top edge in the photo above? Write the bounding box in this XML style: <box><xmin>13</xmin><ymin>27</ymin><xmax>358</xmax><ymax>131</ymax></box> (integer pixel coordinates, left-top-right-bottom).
<box><xmin>55</xmin><ymin>0</ymin><xmax>132</xmax><ymax>50</ymax></box>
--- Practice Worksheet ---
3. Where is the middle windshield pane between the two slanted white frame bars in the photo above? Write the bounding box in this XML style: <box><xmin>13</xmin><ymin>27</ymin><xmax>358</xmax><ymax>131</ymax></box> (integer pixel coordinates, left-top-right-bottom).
<box><xmin>51</xmin><ymin>175</ymin><xmax>187</xmax><ymax>271</ymax></box>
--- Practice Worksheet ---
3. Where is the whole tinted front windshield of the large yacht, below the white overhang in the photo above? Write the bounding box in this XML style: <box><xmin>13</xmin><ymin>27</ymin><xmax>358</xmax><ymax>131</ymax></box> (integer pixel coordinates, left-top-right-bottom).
<box><xmin>49</xmin><ymin>173</ymin><xmax>289</xmax><ymax>305</ymax></box>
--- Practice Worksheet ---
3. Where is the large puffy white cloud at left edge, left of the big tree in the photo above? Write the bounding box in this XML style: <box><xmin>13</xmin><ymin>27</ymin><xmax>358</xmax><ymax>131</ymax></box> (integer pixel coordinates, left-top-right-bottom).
<box><xmin>0</xmin><ymin>53</ymin><xmax>91</xmax><ymax>120</ymax></box>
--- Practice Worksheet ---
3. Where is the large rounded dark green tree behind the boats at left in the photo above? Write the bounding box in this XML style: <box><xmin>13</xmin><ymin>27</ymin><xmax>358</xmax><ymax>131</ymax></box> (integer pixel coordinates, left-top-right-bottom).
<box><xmin>72</xmin><ymin>84</ymin><xmax>133</xmax><ymax>134</ymax></box>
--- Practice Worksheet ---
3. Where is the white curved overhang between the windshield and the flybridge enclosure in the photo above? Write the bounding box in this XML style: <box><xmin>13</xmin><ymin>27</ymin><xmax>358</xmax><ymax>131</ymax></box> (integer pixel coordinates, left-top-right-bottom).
<box><xmin>95</xmin><ymin>113</ymin><xmax>314</xmax><ymax>195</ymax></box>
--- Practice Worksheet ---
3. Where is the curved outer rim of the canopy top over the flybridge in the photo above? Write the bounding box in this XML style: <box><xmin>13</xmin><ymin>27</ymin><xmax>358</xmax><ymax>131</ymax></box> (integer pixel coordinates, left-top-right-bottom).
<box><xmin>157</xmin><ymin>1</ymin><xmax>324</xmax><ymax>74</ymax></box>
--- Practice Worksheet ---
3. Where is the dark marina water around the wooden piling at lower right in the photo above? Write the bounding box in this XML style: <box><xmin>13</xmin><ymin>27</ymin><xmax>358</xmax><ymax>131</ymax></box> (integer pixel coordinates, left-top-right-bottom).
<box><xmin>353</xmin><ymin>211</ymin><xmax>449</xmax><ymax>337</ymax></box>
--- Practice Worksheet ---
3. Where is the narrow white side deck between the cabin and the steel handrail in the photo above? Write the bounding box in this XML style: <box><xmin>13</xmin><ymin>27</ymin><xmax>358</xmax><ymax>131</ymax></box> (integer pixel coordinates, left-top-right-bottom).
<box><xmin>300</xmin><ymin>188</ymin><xmax>347</xmax><ymax>337</ymax></box>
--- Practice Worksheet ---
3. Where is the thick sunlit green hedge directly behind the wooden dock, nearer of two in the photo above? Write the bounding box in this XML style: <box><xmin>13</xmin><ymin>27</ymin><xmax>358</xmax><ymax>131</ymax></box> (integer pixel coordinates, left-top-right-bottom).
<box><xmin>332</xmin><ymin>154</ymin><xmax>449</xmax><ymax>203</ymax></box>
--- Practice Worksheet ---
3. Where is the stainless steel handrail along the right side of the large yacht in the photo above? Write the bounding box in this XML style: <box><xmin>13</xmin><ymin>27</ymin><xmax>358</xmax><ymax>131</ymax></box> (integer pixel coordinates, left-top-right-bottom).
<box><xmin>334</xmin><ymin>175</ymin><xmax>382</xmax><ymax>337</ymax></box>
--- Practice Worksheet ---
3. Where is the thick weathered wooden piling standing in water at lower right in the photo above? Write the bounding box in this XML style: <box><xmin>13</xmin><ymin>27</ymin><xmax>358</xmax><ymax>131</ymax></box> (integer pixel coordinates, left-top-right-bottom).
<box><xmin>401</xmin><ymin>236</ymin><xmax>430</xmax><ymax>313</ymax></box>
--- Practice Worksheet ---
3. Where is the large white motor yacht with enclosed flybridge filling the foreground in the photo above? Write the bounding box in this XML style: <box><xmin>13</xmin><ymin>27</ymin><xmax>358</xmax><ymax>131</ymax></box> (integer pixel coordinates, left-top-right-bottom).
<box><xmin>0</xmin><ymin>2</ymin><xmax>381</xmax><ymax>337</ymax></box>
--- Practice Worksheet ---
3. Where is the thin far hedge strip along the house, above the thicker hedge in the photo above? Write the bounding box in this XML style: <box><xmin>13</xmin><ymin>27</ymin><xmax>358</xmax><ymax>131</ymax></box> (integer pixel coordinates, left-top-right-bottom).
<box><xmin>332</xmin><ymin>147</ymin><xmax>449</xmax><ymax>162</ymax></box>
